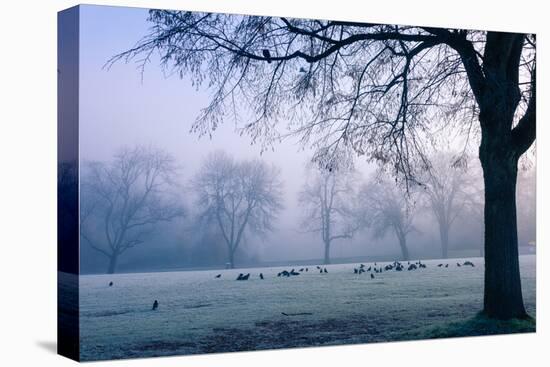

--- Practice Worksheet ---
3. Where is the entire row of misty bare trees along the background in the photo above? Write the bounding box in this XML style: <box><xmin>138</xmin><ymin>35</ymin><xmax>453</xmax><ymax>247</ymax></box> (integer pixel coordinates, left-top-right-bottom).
<box><xmin>75</xmin><ymin>146</ymin><xmax>534</xmax><ymax>273</ymax></box>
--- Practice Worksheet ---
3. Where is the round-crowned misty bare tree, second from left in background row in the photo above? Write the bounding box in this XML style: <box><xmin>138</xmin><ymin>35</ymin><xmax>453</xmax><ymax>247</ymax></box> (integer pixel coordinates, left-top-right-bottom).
<box><xmin>193</xmin><ymin>152</ymin><xmax>282</xmax><ymax>268</ymax></box>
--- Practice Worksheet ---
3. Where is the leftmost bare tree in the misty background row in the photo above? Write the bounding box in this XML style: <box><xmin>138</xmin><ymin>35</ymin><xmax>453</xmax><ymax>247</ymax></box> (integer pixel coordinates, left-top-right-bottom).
<box><xmin>80</xmin><ymin>147</ymin><xmax>183</xmax><ymax>274</ymax></box>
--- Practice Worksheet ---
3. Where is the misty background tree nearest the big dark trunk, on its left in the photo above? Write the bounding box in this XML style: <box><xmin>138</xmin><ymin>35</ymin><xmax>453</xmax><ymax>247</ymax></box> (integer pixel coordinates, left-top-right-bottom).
<box><xmin>421</xmin><ymin>152</ymin><xmax>475</xmax><ymax>259</ymax></box>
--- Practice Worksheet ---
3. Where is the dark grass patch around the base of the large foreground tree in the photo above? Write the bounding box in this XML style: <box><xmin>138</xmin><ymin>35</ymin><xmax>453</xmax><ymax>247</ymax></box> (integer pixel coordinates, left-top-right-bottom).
<box><xmin>410</xmin><ymin>313</ymin><xmax>536</xmax><ymax>339</ymax></box>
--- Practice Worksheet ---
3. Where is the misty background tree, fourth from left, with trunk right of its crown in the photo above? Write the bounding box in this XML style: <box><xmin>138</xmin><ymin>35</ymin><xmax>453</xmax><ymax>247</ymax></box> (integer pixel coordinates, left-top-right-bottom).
<box><xmin>359</xmin><ymin>176</ymin><xmax>415</xmax><ymax>260</ymax></box>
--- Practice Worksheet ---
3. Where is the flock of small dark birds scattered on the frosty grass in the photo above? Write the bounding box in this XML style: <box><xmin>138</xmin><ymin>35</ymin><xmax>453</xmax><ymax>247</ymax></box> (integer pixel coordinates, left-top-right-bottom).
<box><xmin>105</xmin><ymin>260</ymin><xmax>475</xmax><ymax>315</ymax></box>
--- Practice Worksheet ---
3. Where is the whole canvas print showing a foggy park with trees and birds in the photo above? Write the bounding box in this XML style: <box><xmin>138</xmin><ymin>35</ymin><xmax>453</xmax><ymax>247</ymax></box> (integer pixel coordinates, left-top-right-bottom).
<box><xmin>58</xmin><ymin>5</ymin><xmax>539</xmax><ymax>361</ymax></box>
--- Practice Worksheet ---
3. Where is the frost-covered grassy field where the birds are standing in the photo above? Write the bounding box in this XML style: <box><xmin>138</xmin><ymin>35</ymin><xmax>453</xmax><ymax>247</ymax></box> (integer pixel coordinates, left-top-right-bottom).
<box><xmin>80</xmin><ymin>256</ymin><xmax>535</xmax><ymax>360</ymax></box>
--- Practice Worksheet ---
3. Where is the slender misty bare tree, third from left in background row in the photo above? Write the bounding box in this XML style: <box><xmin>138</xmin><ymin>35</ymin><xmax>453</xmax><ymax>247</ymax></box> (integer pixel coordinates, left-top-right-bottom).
<box><xmin>298</xmin><ymin>169</ymin><xmax>359</xmax><ymax>264</ymax></box>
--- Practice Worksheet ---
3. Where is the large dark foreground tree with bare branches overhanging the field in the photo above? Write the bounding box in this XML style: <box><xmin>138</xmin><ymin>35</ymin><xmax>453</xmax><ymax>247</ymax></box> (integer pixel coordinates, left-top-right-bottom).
<box><xmin>111</xmin><ymin>10</ymin><xmax>536</xmax><ymax>319</ymax></box>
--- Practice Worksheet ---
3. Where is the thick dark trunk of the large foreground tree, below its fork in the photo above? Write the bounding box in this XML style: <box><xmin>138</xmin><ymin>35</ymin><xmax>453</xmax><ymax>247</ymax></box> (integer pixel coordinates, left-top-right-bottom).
<box><xmin>480</xmin><ymin>139</ymin><xmax>527</xmax><ymax>319</ymax></box>
